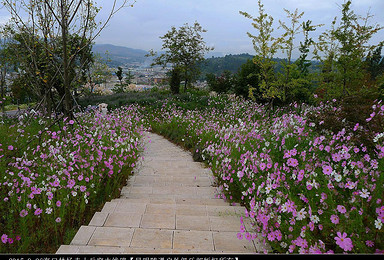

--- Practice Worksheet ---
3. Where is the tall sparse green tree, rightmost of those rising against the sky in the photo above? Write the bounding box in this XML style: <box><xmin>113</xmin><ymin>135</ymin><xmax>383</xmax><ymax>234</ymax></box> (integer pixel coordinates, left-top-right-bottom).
<box><xmin>318</xmin><ymin>0</ymin><xmax>383</xmax><ymax>97</ymax></box>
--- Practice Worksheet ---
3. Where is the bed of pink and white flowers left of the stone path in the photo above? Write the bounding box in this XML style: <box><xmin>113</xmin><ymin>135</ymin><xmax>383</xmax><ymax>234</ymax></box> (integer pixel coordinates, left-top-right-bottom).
<box><xmin>0</xmin><ymin>106</ymin><xmax>143</xmax><ymax>252</ymax></box>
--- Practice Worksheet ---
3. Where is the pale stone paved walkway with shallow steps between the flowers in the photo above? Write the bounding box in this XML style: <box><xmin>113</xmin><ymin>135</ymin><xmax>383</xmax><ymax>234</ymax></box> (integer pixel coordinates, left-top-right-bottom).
<box><xmin>57</xmin><ymin>133</ymin><xmax>262</xmax><ymax>254</ymax></box>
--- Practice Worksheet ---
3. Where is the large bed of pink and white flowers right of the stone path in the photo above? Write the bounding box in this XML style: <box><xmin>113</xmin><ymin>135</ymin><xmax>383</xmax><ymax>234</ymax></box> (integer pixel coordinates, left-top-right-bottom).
<box><xmin>149</xmin><ymin>96</ymin><xmax>384</xmax><ymax>253</ymax></box>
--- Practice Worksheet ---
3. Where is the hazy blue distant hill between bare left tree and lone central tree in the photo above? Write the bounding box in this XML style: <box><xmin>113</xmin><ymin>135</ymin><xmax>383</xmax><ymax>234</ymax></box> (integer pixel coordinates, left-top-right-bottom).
<box><xmin>92</xmin><ymin>44</ymin><xmax>148</xmax><ymax>67</ymax></box>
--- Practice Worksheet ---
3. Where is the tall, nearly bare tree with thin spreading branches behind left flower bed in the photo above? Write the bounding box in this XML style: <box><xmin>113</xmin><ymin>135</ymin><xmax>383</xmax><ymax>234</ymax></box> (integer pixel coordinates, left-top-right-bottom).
<box><xmin>3</xmin><ymin>0</ymin><xmax>135</xmax><ymax>118</ymax></box>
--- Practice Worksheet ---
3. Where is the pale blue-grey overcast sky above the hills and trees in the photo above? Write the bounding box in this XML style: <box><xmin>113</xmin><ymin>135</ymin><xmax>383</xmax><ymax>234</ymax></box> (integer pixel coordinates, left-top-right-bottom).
<box><xmin>0</xmin><ymin>0</ymin><xmax>384</xmax><ymax>58</ymax></box>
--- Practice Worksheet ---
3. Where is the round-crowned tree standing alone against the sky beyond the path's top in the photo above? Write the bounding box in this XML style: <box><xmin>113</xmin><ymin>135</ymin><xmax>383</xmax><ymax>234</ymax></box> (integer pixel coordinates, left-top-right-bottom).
<box><xmin>149</xmin><ymin>22</ymin><xmax>213</xmax><ymax>91</ymax></box>
